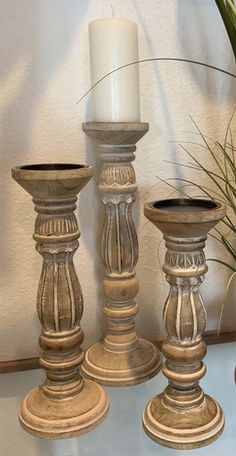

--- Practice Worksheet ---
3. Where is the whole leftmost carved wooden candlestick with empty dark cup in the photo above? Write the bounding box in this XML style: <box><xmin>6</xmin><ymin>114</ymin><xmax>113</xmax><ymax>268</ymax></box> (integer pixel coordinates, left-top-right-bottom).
<box><xmin>12</xmin><ymin>164</ymin><xmax>108</xmax><ymax>438</ymax></box>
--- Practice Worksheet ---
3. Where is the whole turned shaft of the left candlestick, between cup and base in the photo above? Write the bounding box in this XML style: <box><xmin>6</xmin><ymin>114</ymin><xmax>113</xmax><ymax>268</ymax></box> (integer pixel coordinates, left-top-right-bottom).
<box><xmin>30</xmin><ymin>197</ymin><xmax>83</xmax><ymax>384</ymax></box>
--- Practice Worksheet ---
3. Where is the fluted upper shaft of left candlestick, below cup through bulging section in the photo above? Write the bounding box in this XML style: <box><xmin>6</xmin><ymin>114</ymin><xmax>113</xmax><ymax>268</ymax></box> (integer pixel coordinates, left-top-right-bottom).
<box><xmin>34</xmin><ymin>198</ymin><xmax>83</xmax><ymax>332</ymax></box>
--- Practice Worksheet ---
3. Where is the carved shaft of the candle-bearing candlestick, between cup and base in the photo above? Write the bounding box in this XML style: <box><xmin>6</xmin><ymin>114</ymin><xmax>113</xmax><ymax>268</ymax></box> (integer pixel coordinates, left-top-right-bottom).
<box><xmin>99</xmin><ymin>145</ymin><xmax>138</xmax><ymax>352</ymax></box>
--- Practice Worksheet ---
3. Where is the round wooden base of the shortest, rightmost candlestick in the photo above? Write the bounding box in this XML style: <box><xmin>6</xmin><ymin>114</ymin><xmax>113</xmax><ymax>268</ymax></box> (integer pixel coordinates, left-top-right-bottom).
<box><xmin>143</xmin><ymin>394</ymin><xmax>224</xmax><ymax>450</ymax></box>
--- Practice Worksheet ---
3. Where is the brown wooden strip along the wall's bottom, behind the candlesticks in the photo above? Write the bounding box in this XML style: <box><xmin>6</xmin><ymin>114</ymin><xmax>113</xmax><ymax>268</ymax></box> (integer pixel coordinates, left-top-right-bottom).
<box><xmin>0</xmin><ymin>331</ymin><xmax>236</xmax><ymax>374</ymax></box>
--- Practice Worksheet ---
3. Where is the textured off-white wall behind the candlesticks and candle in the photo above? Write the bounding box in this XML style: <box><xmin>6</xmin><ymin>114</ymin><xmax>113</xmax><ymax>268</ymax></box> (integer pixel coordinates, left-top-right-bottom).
<box><xmin>0</xmin><ymin>0</ymin><xmax>236</xmax><ymax>360</ymax></box>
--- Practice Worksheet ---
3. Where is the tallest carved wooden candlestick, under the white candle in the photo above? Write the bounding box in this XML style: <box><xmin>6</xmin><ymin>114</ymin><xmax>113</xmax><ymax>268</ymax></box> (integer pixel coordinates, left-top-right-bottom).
<box><xmin>82</xmin><ymin>122</ymin><xmax>161</xmax><ymax>386</ymax></box>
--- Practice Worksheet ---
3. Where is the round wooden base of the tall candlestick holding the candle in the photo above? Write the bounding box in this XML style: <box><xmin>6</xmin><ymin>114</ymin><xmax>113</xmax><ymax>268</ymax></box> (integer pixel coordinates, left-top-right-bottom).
<box><xmin>81</xmin><ymin>339</ymin><xmax>162</xmax><ymax>386</ymax></box>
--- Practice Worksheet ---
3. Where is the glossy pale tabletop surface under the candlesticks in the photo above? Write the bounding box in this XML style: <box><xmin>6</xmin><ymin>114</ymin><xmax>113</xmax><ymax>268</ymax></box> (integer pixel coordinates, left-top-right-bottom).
<box><xmin>0</xmin><ymin>343</ymin><xmax>236</xmax><ymax>456</ymax></box>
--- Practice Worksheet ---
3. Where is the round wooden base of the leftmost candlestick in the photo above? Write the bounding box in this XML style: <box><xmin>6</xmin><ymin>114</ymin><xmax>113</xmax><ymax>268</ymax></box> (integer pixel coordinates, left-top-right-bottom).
<box><xmin>19</xmin><ymin>380</ymin><xmax>109</xmax><ymax>439</ymax></box>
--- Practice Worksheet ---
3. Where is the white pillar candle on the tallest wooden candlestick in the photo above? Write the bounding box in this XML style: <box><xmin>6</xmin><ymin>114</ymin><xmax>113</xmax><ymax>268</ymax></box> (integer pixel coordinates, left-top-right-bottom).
<box><xmin>89</xmin><ymin>18</ymin><xmax>140</xmax><ymax>122</ymax></box>
